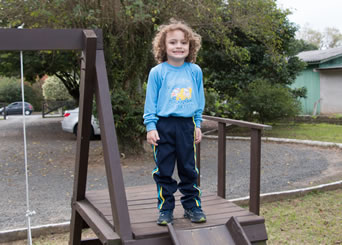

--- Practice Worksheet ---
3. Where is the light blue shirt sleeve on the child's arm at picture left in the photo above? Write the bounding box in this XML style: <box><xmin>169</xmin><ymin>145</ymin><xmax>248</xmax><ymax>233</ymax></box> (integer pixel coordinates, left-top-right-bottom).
<box><xmin>143</xmin><ymin>68</ymin><xmax>159</xmax><ymax>132</ymax></box>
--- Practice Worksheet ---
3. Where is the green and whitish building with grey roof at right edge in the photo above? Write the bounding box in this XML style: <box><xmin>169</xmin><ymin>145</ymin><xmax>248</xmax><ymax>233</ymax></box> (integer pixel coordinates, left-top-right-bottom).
<box><xmin>291</xmin><ymin>47</ymin><xmax>342</xmax><ymax>115</ymax></box>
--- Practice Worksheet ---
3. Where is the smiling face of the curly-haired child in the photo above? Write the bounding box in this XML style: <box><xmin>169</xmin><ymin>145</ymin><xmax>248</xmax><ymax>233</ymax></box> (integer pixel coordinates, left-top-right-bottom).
<box><xmin>165</xmin><ymin>30</ymin><xmax>189</xmax><ymax>65</ymax></box>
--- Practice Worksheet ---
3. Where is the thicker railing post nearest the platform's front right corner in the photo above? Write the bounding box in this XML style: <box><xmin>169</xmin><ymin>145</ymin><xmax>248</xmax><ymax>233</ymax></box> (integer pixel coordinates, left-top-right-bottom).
<box><xmin>249</xmin><ymin>129</ymin><xmax>261</xmax><ymax>215</ymax></box>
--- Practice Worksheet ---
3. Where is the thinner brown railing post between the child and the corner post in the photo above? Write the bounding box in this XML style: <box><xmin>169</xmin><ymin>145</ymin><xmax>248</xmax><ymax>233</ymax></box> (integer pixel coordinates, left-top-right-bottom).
<box><xmin>217</xmin><ymin>122</ymin><xmax>226</xmax><ymax>198</ymax></box>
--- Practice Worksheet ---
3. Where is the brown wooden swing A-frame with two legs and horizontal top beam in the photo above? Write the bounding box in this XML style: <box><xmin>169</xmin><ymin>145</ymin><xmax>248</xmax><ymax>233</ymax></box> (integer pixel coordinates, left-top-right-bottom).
<box><xmin>0</xmin><ymin>29</ymin><xmax>133</xmax><ymax>244</ymax></box>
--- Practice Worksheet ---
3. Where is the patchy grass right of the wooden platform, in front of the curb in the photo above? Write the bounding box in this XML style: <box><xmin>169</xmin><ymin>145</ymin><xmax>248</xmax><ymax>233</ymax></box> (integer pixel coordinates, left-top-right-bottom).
<box><xmin>261</xmin><ymin>189</ymin><xmax>342</xmax><ymax>244</ymax></box>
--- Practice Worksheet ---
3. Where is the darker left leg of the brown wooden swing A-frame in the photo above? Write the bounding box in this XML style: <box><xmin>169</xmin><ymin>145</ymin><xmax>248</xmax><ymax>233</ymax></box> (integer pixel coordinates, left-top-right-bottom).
<box><xmin>70</xmin><ymin>30</ymin><xmax>97</xmax><ymax>245</ymax></box>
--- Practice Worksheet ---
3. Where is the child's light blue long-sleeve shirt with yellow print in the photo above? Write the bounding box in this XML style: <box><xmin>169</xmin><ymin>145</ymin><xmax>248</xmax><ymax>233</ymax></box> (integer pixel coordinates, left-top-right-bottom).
<box><xmin>144</xmin><ymin>62</ymin><xmax>205</xmax><ymax>131</ymax></box>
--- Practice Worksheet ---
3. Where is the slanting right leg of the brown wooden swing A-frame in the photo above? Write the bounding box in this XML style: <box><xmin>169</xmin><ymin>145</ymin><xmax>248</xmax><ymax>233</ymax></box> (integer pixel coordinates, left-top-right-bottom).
<box><xmin>95</xmin><ymin>50</ymin><xmax>133</xmax><ymax>241</ymax></box>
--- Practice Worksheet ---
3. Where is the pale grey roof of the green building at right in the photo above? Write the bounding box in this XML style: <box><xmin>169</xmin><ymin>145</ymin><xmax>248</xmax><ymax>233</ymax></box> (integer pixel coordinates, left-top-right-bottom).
<box><xmin>297</xmin><ymin>46</ymin><xmax>342</xmax><ymax>63</ymax></box>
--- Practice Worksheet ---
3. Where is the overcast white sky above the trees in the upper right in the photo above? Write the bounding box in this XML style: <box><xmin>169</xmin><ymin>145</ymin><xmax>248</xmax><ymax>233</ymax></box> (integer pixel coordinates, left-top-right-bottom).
<box><xmin>277</xmin><ymin>0</ymin><xmax>342</xmax><ymax>33</ymax></box>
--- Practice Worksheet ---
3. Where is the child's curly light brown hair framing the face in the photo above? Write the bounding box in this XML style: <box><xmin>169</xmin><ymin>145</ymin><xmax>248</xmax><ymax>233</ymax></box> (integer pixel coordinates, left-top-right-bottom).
<box><xmin>152</xmin><ymin>19</ymin><xmax>201</xmax><ymax>64</ymax></box>
